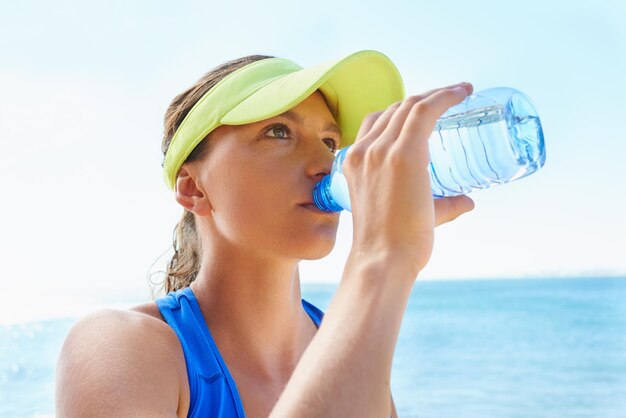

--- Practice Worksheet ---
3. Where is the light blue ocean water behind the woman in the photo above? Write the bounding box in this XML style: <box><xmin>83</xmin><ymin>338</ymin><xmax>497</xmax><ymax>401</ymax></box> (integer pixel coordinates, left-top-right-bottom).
<box><xmin>0</xmin><ymin>277</ymin><xmax>626</xmax><ymax>418</ymax></box>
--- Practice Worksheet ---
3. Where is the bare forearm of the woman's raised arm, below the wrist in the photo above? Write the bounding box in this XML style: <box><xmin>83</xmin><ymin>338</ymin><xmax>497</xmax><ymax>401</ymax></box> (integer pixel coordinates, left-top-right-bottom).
<box><xmin>271</xmin><ymin>250</ymin><xmax>413</xmax><ymax>418</ymax></box>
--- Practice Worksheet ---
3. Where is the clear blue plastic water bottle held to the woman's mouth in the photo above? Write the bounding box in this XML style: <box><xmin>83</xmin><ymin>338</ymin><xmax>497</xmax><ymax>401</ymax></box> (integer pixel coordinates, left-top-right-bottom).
<box><xmin>313</xmin><ymin>87</ymin><xmax>546</xmax><ymax>212</ymax></box>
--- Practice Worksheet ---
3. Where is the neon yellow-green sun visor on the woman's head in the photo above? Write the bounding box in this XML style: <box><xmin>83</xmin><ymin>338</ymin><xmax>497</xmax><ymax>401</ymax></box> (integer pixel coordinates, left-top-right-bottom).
<box><xmin>163</xmin><ymin>51</ymin><xmax>404</xmax><ymax>189</ymax></box>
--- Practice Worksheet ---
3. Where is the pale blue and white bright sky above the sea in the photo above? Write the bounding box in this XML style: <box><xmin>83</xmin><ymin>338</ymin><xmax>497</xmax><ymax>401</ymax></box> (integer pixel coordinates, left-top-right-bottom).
<box><xmin>0</xmin><ymin>0</ymin><xmax>626</xmax><ymax>316</ymax></box>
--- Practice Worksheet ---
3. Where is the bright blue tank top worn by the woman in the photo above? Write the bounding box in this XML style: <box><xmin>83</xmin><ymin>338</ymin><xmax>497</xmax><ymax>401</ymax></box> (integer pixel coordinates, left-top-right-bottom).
<box><xmin>156</xmin><ymin>287</ymin><xmax>324</xmax><ymax>418</ymax></box>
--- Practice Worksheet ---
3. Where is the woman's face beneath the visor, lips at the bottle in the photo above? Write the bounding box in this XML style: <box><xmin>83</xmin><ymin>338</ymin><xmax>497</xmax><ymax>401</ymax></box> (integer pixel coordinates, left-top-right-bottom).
<box><xmin>190</xmin><ymin>92</ymin><xmax>341</xmax><ymax>260</ymax></box>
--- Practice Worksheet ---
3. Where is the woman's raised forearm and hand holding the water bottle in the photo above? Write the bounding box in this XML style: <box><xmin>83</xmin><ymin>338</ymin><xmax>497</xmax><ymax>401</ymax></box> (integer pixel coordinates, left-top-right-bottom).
<box><xmin>271</xmin><ymin>85</ymin><xmax>473</xmax><ymax>418</ymax></box>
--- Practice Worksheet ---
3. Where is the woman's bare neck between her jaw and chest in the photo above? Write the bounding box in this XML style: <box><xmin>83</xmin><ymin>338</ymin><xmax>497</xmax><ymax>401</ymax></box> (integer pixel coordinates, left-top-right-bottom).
<box><xmin>191</xmin><ymin>248</ymin><xmax>315</xmax><ymax>380</ymax></box>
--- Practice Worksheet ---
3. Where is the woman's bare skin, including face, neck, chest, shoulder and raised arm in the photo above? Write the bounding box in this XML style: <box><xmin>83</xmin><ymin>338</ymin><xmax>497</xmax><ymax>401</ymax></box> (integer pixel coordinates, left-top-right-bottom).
<box><xmin>57</xmin><ymin>85</ymin><xmax>473</xmax><ymax>417</ymax></box>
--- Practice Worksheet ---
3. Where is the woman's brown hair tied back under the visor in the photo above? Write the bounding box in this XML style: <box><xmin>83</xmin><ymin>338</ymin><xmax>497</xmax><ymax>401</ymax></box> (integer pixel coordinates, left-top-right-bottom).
<box><xmin>161</xmin><ymin>55</ymin><xmax>274</xmax><ymax>294</ymax></box>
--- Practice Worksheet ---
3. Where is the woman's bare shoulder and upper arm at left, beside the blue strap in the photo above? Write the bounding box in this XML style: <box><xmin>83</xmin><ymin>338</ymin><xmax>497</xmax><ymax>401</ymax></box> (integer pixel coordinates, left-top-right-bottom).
<box><xmin>56</xmin><ymin>310</ymin><xmax>186</xmax><ymax>418</ymax></box>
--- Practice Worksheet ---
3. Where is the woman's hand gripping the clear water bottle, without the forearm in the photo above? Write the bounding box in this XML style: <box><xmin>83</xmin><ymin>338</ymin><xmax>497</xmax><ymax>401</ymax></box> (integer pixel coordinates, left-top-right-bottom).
<box><xmin>343</xmin><ymin>83</ymin><xmax>474</xmax><ymax>278</ymax></box>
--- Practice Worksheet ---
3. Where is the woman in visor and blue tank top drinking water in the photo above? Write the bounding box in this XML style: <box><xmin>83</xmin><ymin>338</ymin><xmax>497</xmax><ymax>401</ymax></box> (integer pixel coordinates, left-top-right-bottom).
<box><xmin>57</xmin><ymin>51</ymin><xmax>473</xmax><ymax>417</ymax></box>
